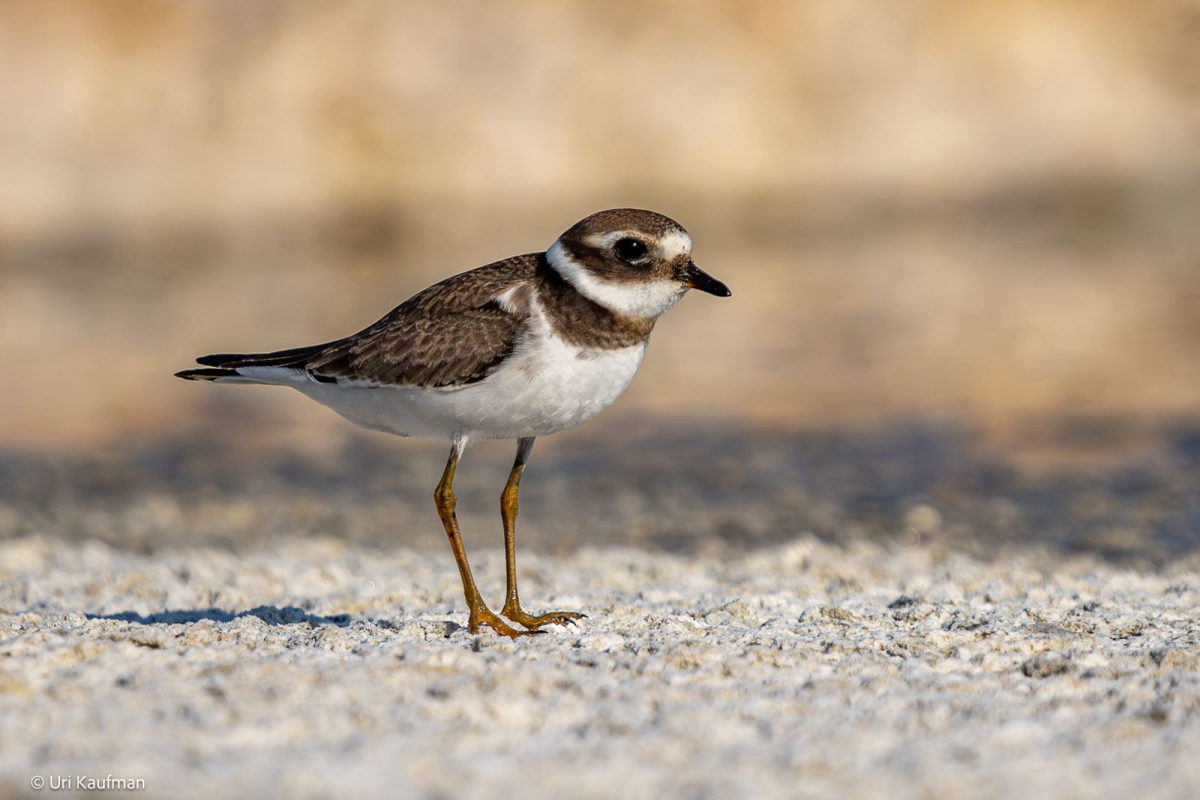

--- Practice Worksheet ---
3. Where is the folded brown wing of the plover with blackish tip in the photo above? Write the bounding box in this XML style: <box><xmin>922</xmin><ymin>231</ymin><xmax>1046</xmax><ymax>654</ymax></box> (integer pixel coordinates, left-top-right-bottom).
<box><xmin>199</xmin><ymin>254</ymin><xmax>540</xmax><ymax>389</ymax></box>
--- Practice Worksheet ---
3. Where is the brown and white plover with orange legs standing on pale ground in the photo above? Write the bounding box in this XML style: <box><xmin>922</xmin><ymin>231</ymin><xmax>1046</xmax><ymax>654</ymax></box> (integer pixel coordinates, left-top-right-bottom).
<box><xmin>175</xmin><ymin>209</ymin><xmax>731</xmax><ymax>638</ymax></box>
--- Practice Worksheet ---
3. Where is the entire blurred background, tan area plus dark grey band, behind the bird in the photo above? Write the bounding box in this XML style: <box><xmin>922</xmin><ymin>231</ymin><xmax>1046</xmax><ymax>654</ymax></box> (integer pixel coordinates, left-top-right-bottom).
<box><xmin>0</xmin><ymin>0</ymin><xmax>1200</xmax><ymax>563</ymax></box>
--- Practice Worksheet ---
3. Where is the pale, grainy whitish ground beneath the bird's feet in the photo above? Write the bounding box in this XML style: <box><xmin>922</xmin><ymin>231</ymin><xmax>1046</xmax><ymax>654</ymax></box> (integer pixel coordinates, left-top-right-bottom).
<box><xmin>0</xmin><ymin>536</ymin><xmax>1200</xmax><ymax>798</ymax></box>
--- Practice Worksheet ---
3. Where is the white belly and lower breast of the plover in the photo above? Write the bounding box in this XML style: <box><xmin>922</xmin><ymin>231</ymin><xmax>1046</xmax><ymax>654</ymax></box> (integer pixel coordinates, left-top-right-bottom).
<box><xmin>292</xmin><ymin>333</ymin><xmax>646</xmax><ymax>440</ymax></box>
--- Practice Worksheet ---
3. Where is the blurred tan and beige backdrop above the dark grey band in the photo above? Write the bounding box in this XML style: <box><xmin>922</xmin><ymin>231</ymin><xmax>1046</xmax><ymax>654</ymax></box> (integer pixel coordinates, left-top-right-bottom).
<box><xmin>0</xmin><ymin>0</ymin><xmax>1200</xmax><ymax>460</ymax></box>
